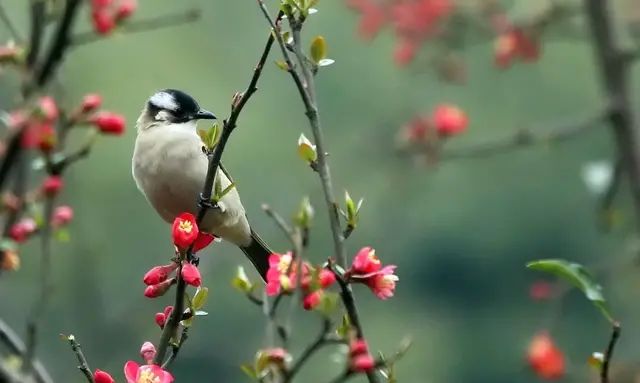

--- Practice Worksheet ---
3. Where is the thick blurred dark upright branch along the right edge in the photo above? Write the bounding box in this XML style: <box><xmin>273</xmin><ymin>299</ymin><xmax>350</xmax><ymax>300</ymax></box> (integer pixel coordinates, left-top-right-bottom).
<box><xmin>584</xmin><ymin>0</ymin><xmax>640</xmax><ymax>227</ymax></box>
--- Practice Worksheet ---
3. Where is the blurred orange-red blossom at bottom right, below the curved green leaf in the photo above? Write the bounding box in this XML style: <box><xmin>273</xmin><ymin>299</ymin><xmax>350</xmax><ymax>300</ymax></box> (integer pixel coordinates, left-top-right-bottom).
<box><xmin>527</xmin><ymin>331</ymin><xmax>565</xmax><ymax>380</ymax></box>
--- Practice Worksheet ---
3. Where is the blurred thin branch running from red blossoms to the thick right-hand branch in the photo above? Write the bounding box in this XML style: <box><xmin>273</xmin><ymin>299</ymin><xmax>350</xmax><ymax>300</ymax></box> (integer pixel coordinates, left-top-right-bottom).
<box><xmin>430</xmin><ymin>109</ymin><xmax>609</xmax><ymax>160</ymax></box>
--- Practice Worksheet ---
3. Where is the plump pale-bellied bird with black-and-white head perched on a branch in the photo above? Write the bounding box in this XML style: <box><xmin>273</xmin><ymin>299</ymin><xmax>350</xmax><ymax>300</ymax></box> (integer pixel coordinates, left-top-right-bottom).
<box><xmin>131</xmin><ymin>89</ymin><xmax>271</xmax><ymax>280</ymax></box>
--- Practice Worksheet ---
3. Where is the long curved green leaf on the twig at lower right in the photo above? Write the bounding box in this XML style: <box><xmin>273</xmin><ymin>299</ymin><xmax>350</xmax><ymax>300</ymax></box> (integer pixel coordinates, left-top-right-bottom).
<box><xmin>527</xmin><ymin>259</ymin><xmax>613</xmax><ymax>322</ymax></box>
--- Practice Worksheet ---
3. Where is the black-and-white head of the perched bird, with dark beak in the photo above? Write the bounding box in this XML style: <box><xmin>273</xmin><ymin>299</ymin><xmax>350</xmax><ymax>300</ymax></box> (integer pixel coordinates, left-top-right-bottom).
<box><xmin>138</xmin><ymin>89</ymin><xmax>216</xmax><ymax>130</ymax></box>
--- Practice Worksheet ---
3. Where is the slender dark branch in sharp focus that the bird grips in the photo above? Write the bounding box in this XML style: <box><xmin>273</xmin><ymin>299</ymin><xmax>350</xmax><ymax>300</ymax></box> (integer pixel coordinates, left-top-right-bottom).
<box><xmin>154</xmin><ymin>13</ymin><xmax>282</xmax><ymax>365</ymax></box>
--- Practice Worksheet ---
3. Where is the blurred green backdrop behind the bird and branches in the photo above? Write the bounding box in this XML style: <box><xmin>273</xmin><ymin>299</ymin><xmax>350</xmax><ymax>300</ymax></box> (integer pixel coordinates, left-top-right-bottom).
<box><xmin>0</xmin><ymin>0</ymin><xmax>640</xmax><ymax>383</ymax></box>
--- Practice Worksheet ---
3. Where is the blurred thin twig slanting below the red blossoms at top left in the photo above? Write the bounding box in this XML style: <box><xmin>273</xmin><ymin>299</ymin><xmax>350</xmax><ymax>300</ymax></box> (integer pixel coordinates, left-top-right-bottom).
<box><xmin>71</xmin><ymin>8</ymin><xmax>202</xmax><ymax>47</ymax></box>
